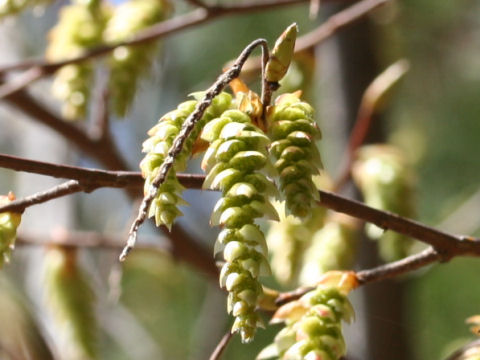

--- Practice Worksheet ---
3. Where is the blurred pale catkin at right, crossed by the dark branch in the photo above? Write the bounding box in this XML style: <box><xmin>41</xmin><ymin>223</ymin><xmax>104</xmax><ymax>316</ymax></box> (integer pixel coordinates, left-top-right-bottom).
<box><xmin>352</xmin><ymin>145</ymin><xmax>414</xmax><ymax>261</ymax></box>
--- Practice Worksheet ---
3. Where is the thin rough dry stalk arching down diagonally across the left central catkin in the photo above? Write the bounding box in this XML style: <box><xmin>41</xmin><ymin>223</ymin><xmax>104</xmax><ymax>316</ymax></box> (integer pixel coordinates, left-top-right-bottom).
<box><xmin>120</xmin><ymin>39</ymin><xmax>268</xmax><ymax>261</ymax></box>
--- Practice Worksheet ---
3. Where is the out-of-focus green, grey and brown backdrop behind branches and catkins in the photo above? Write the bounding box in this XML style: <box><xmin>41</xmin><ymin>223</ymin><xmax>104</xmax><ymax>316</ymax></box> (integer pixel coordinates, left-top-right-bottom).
<box><xmin>0</xmin><ymin>0</ymin><xmax>480</xmax><ymax>360</ymax></box>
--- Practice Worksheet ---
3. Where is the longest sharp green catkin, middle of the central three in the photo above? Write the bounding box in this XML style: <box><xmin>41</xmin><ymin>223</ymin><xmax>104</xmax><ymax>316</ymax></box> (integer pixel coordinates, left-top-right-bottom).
<box><xmin>201</xmin><ymin>105</ymin><xmax>278</xmax><ymax>342</ymax></box>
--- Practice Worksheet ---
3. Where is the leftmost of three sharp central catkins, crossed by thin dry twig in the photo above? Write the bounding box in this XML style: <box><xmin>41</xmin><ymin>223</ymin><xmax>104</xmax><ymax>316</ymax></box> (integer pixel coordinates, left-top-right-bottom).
<box><xmin>140</xmin><ymin>93</ymin><xmax>232</xmax><ymax>229</ymax></box>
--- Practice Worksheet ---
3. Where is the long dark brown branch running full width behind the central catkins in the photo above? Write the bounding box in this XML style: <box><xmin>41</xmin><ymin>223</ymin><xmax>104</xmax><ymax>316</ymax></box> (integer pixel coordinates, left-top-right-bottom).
<box><xmin>0</xmin><ymin>154</ymin><xmax>480</xmax><ymax>261</ymax></box>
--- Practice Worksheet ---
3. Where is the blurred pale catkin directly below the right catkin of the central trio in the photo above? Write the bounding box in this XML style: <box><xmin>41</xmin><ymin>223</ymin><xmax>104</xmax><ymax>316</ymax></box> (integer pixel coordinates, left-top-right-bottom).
<box><xmin>267</xmin><ymin>204</ymin><xmax>326</xmax><ymax>287</ymax></box>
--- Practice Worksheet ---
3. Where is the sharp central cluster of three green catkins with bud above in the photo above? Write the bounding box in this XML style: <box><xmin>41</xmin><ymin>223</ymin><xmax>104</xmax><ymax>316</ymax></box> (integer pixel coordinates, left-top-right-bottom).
<box><xmin>137</xmin><ymin>22</ymin><xmax>332</xmax><ymax>342</ymax></box>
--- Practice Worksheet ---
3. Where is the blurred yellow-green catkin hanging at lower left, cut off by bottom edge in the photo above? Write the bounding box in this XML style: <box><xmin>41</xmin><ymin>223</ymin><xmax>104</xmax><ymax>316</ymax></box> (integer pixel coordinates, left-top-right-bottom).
<box><xmin>44</xmin><ymin>246</ymin><xmax>98</xmax><ymax>360</ymax></box>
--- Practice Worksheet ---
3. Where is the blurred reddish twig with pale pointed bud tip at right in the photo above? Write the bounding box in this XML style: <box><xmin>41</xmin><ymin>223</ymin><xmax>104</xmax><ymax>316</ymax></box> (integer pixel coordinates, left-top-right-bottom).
<box><xmin>335</xmin><ymin>59</ymin><xmax>410</xmax><ymax>191</ymax></box>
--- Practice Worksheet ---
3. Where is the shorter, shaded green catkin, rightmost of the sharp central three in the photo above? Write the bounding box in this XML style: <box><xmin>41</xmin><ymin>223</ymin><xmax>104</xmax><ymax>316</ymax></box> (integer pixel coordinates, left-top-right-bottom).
<box><xmin>268</xmin><ymin>93</ymin><xmax>322</xmax><ymax>218</ymax></box>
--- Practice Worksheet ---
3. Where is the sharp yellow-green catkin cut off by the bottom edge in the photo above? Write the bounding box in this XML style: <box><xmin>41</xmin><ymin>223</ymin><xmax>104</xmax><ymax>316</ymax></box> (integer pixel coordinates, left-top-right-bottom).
<box><xmin>257</xmin><ymin>286</ymin><xmax>354</xmax><ymax>360</ymax></box>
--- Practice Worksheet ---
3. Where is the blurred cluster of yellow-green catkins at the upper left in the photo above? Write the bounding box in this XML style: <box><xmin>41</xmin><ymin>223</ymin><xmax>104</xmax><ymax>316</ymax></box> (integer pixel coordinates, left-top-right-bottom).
<box><xmin>47</xmin><ymin>0</ymin><xmax>170</xmax><ymax>120</ymax></box>
